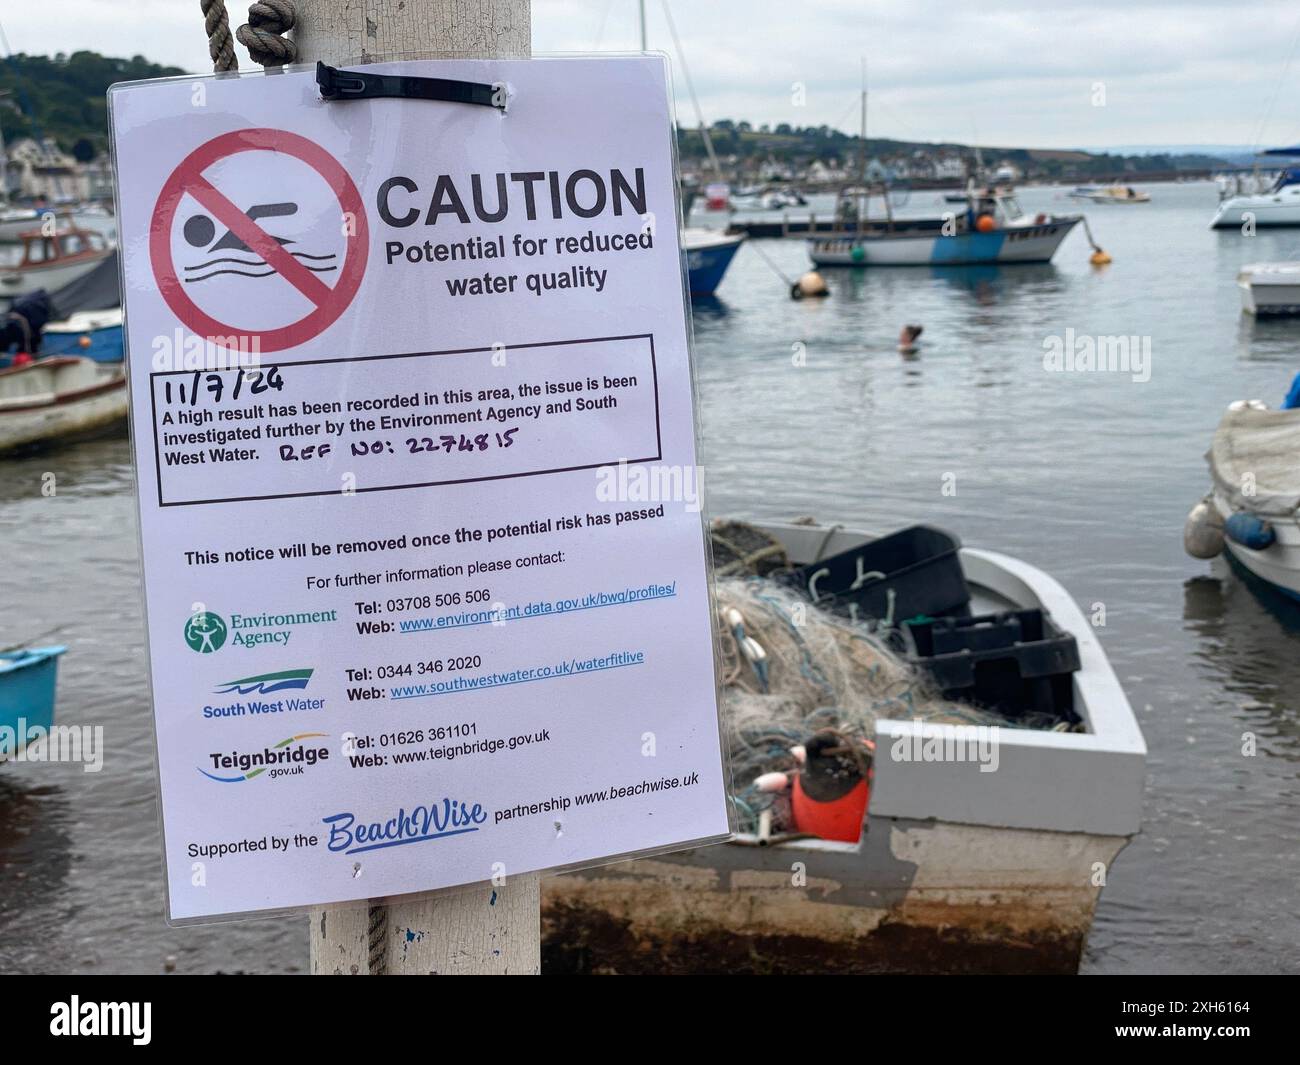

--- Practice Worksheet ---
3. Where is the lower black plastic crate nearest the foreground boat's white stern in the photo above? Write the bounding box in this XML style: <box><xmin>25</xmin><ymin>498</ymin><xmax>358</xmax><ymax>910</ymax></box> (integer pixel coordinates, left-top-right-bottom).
<box><xmin>904</xmin><ymin>610</ymin><xmax>1079</xmax><ymax>720</ymax></box>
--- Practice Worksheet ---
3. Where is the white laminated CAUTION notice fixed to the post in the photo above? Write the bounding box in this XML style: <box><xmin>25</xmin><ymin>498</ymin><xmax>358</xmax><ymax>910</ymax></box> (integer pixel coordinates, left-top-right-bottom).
<box><xmin>111</xmin><ymin>59</ymin><xmax>728</xmax><ymax>921</ymax></box>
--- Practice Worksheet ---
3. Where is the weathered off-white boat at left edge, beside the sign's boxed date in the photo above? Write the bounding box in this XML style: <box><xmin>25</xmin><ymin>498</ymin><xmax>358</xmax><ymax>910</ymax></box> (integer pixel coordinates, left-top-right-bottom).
<box><xmin>0</xmin><ymin>355</ymin><xmax>126</xmax><ymax>455</ymax></box>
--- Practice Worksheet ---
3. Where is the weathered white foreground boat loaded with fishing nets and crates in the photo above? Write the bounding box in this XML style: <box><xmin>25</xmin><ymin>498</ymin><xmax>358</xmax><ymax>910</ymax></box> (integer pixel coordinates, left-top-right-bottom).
<box><xmin>542</xmin><ymin>524</ymin><xmax>1147</xmax><ymax>973</ymax></box>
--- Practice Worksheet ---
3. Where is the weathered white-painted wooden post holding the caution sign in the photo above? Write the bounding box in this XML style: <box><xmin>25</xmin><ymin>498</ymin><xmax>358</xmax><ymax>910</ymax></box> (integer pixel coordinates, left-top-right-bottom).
<box><xmin>294</xmin><ymin>0</ymin><xmax>541</xmax><ymax>975</ymax></box>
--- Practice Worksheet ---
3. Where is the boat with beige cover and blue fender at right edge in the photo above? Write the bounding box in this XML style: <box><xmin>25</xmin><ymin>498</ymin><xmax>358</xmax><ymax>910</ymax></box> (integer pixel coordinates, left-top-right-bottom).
<box><xmin>1183</xmin><ymin>399</ymin><xmax>1300</xmax><ymax>599</ymax></box>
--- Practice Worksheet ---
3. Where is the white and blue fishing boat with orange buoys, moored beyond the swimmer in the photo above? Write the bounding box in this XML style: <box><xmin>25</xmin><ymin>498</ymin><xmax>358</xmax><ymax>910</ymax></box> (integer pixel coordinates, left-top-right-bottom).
<box><xmin>809</xmin><ymin>189</ymin><xmax>1083</xmax><ymax>267</ymax></box>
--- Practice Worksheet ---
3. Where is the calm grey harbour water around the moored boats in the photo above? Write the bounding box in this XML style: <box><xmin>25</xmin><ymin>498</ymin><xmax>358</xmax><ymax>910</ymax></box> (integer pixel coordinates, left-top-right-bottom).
<box><xmin>0</xmin><ymin>183</ymin><xmax>1300</xmax><ymax>973</ymax></box>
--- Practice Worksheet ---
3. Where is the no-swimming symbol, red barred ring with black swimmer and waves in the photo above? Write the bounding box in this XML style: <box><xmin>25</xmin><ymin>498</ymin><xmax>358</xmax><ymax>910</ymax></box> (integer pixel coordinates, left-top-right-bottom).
<box><xmin>150</xmin><ymin>129</ymin><xmax>369</xmax><ymax>351</ymax></box>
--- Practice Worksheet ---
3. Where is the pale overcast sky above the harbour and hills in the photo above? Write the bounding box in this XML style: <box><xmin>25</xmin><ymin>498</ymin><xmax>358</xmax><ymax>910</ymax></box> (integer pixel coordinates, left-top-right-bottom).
<box><xmin>0</xmin><ymin>0</ymin><xmax>1300</xmax><ymax>147</ymax></box>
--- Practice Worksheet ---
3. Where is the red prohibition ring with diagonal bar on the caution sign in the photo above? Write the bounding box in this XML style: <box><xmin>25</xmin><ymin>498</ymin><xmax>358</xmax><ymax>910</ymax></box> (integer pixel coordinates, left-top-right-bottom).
<box><xmin>150</xmin><ymin>129</ymin><xmax>369</xmax><ymax>351</ymax></box>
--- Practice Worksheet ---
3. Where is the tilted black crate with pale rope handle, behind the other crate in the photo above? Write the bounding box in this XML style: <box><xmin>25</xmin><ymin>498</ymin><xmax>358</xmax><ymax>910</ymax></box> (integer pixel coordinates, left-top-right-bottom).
<box><xmin>790</xmin><ymin>525</ymin><xmax>971</xmax><ymax>625</ymax></box>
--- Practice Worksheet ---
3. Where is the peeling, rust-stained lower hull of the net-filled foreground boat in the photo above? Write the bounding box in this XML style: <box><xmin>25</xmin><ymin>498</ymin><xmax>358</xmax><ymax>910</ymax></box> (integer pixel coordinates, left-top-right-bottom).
<box><xmin>542</xmin><ymin>818</ymin><xmax>1127</xmax><ymax>973</ymax></box>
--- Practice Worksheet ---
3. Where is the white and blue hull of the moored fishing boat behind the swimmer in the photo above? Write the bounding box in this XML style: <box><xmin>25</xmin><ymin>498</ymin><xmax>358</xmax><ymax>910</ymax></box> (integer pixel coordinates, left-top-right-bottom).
<box><xmin>809</xmin><ymin>218</ymin><xmax>1079</xmax><ymax>267</ymax></box>
